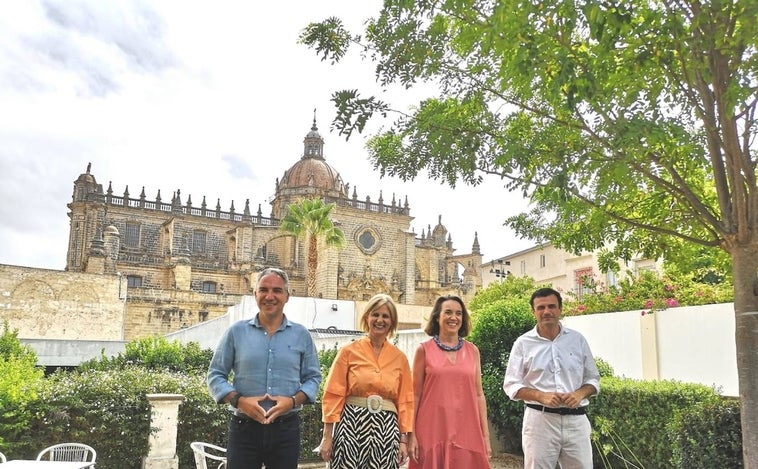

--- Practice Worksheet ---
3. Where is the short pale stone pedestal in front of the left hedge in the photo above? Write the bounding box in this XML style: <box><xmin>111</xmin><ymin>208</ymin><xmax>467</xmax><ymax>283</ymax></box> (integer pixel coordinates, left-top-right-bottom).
<box><xmin>142</xmin><ymin>394</ymin><xmax>184</xmax><ymax>469</ymax></box>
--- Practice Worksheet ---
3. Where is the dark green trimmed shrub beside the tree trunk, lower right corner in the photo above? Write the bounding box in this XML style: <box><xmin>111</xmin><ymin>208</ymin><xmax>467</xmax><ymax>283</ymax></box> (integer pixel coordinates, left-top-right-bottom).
<box><xmin>668</xmin><ymin>399</ymin><xmax>743</xmax><ymax>469</ymax></box>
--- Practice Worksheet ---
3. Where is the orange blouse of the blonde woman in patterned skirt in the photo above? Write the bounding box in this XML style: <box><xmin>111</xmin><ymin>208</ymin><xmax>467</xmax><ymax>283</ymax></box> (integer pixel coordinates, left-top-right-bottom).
<box><xmin>321</xmin><ymin>337</ymin><xmax>413</xmax><ymax>433</ymax></box>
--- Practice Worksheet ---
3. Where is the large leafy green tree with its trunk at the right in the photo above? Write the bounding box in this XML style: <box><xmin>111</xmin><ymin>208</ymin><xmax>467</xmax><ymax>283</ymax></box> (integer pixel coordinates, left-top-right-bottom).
<box><xmin>300</xmin><ymin>0</ymin><xmax>758</xmax><ymax>467</ymax></box>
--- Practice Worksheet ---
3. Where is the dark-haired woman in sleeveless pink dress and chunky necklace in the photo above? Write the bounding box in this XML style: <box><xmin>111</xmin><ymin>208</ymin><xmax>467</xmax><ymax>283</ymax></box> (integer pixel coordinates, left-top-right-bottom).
<box><xmin>408</xmin><ymin>295</ymin><xmax>492</xmax><ymax>469</ymax></box>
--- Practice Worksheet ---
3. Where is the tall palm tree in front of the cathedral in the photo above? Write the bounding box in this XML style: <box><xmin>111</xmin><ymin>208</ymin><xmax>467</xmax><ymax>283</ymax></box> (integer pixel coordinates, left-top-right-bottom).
<box><xmin>279</xmin><ymin>199</ymin><xmax>345</xmax><ymax>296</ymax></box>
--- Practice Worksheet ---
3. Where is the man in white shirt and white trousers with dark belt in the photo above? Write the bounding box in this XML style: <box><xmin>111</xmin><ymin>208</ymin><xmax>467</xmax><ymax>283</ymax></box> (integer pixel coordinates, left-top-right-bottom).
<box><xmin>503</xmin><ymin>288</ymin><xmax>600</xmax><ymax>469</ymax></box>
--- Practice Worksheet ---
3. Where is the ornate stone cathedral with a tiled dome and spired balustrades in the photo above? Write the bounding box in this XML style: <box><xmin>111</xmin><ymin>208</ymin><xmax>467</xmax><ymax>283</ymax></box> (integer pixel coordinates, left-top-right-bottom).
<box><xmin>66</xmin><ymin>118</ymin><xmax>482</xmax><ymax>337</ymax></box>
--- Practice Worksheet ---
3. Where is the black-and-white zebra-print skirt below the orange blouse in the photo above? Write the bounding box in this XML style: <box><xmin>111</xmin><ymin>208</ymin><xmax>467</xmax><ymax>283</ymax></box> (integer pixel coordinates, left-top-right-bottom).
<box><xmin>329</xmin><ymin>405</ymin><xmax>400</xmax><ymax>469</ymax></box>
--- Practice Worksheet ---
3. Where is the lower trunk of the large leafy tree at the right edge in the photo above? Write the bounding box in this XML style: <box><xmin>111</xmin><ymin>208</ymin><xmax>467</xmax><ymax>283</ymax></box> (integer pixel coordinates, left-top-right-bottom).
<box><xmin>731</xmin><ymin>244</ymin><xmax>758</xmax><ymax>469</ymax></box>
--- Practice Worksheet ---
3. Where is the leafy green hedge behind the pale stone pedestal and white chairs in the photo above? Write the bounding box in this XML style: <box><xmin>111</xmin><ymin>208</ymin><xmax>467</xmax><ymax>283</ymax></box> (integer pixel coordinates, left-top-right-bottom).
<box><xmin>15</xmin><ymin>366</ymin><xmax>229</xmax><ymax>469</ymax></box>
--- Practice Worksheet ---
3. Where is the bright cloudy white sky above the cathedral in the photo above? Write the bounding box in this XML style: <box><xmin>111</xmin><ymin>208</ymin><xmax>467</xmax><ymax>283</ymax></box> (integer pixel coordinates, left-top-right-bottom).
<box><xmin>0</xmin><ymin>0</ymin><xmax>533</xmax><ymax>269</ymax></box>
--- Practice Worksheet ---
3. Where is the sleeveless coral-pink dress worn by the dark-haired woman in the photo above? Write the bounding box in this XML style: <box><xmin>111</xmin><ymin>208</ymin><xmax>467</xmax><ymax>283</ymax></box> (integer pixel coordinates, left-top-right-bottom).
<box><xmin>408</xmin><ymin>339</ymin><xmax>490</xmax><ymax>469</ymax></box>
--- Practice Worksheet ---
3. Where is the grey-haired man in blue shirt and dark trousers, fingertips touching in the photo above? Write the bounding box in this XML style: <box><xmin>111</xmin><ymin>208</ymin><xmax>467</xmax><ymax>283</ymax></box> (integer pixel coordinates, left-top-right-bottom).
<box><xmin>208</xmin><ymin>268</ymin><xmax>321</xmax><ymax>469</ymax></box>
